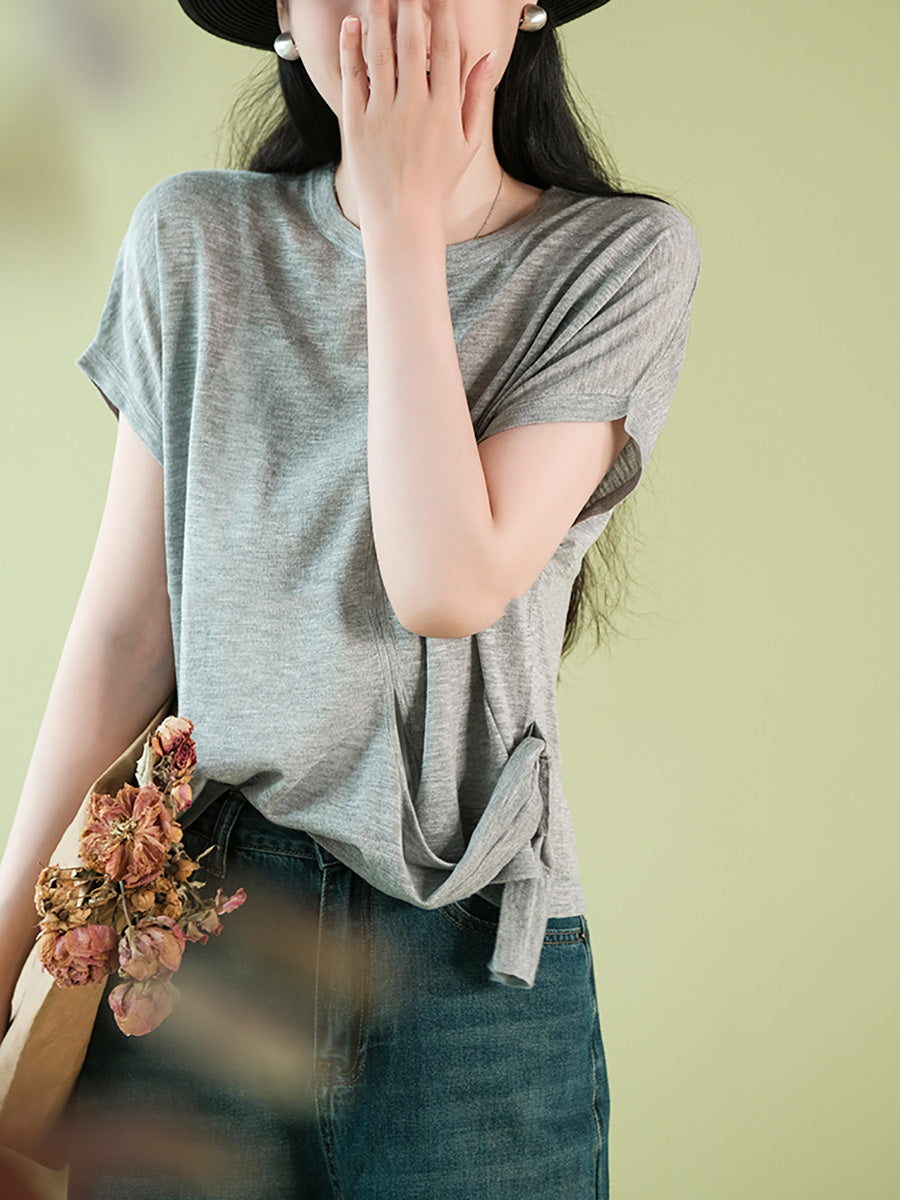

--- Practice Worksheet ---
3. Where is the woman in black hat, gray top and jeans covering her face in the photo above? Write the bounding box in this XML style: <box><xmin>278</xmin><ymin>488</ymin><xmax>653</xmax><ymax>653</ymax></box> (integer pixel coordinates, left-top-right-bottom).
<box><xmin>5</xmin><ymin>0</ymin><xmax>700</xmax><ymax>1200</ymax></box>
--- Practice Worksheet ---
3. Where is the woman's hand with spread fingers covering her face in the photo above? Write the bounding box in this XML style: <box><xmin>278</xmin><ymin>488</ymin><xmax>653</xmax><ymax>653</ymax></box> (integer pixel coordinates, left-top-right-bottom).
<box><xmin>341</xmin><ymin>0</ymin><xmax>492</xmax><ymax>235</ymax></box>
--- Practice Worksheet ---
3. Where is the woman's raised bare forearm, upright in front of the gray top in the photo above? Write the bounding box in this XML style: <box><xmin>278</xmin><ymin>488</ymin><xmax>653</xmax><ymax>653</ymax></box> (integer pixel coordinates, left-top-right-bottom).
<box><xmin>362</xmin><ymin>214</ymin><xmax>509</xmax><ymax>637</ymax></box>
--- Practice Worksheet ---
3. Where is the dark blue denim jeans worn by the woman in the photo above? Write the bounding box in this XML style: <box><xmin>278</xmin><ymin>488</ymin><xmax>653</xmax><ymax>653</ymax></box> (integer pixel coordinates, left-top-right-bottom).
<box><xmin>67</xmin><ymin>788</ymin><xmax>610</xmax><ymax>1200</ymax></box>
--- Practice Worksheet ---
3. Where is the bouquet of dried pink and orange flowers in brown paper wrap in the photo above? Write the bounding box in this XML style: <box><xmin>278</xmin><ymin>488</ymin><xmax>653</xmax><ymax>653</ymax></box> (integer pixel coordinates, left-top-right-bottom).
<box><xmin>35</xmin><ymin>716</ymin><xmax>246</xmax><ymax>1036</ymax></box>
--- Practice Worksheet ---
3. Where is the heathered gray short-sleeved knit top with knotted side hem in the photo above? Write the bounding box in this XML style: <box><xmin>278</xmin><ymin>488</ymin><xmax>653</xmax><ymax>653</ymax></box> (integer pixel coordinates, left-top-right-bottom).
<box><xmin>78</xmin><ymin>167</ymin><xmax>700</xmax><ymax>988</ymax></box>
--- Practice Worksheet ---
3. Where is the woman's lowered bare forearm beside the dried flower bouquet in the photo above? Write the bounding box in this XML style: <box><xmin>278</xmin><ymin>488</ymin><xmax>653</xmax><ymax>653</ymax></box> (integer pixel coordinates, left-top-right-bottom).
<box><xmin>0</xmin><ymin>607</ymin><xmax>175</xmax><ymax>998</ymax></box>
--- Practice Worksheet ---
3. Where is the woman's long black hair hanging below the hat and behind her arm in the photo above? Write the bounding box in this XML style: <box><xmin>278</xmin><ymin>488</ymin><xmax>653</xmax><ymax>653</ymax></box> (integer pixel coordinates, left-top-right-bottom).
<box><xmin>218</xmin><ymin>14</ymin><xmax>691</xmax><ymax>661</ymax></box>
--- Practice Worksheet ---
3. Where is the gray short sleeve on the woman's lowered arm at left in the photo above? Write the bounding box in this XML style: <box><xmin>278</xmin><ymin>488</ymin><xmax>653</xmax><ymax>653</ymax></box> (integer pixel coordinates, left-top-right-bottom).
<box><xmin>76</xmin><ymin>193</ymin><xmax>163</xmax><ymax>463</ymax></box>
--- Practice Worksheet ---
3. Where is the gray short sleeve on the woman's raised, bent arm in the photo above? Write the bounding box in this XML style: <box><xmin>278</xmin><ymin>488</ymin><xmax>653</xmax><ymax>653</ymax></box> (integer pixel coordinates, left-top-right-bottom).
<box><xmin>478</xmin><ymin>208</ymin><xmax>701</xmax><ymax>524</ymax></box>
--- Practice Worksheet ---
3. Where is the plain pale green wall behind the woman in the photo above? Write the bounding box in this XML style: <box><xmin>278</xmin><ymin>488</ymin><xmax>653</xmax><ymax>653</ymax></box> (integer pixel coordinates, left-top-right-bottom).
<box><xmin>0</xmin><ymin>0</ymin><xmax>900</xmax><ymax>1200</ymax></box>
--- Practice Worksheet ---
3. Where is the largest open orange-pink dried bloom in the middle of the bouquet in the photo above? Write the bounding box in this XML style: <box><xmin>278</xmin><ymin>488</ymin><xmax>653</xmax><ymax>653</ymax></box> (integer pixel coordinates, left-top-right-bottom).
<box><xmin>80</xmin><ymin>784</ymin><xmax>181</xmax><ymax>888</ymax></box>
